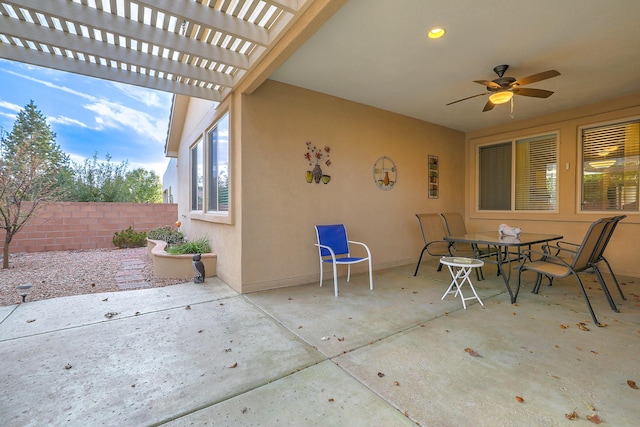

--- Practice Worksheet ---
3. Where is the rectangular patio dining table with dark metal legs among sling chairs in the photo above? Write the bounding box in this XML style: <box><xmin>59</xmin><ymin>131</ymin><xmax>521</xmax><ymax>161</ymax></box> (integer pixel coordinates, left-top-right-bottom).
<box><xmin>444</xmin><ymin>231</ymin><xmax>563</xmax><ymax>304</ymax></box>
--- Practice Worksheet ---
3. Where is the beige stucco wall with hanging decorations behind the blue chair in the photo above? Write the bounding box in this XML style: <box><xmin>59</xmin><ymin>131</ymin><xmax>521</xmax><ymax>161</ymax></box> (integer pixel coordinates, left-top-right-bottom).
<box><xmin>240</xmin><ymin>81</ymin><xmax>464</xmax><ymax>292</ymax></box>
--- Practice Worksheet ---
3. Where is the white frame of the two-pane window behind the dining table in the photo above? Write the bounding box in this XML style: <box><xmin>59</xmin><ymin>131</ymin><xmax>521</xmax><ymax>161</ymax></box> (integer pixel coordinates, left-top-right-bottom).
<box><xmin>476</xmin><ymin>131</ymin><xmax>560</xmax><ymax>214</ymax></box>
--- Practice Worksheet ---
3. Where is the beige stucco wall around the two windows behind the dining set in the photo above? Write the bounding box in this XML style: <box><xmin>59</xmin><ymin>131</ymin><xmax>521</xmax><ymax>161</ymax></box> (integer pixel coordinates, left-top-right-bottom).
<box><xmin>465</xmin><ymin>94</ymin><xmax>640</xmax><ymax>277</ymax></box>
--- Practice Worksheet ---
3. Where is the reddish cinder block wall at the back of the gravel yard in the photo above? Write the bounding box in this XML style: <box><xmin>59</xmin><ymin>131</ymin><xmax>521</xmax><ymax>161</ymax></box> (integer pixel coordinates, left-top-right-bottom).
<box><xmin>10</xmin><ymin>202</ymin><xmax>178</xmax><ymax>253</ymax></box>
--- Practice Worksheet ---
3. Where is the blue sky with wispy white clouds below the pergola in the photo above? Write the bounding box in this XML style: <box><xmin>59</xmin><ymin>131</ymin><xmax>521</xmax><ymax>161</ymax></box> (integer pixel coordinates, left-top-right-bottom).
<box><xmin>0</xmin><ymin>59</ymin><xmax>172</xmax><ymax>179</ymax></box>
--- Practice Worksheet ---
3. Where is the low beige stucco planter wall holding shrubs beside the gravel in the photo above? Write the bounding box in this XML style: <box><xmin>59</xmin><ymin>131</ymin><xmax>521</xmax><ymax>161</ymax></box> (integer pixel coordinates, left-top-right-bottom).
<box><xmin>147</xmin><ymin>239</ymin><xmax>218</xmax><ymax>280</ymax></box>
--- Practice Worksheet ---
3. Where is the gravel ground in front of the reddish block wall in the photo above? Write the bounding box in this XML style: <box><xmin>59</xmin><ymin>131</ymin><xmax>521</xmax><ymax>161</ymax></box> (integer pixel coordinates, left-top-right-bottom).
<box><xmin>0</xmin><ymin>248</ymin><xmax>185</xmax><ymax>306</ymax></box>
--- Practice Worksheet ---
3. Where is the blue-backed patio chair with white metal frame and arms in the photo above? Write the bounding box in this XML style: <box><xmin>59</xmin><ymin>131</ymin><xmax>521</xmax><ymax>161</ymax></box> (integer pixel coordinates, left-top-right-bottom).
<box><xmin>315</xmin><ymin>224</ymin><xmax>373</xmax><ymax>297</ymax></box>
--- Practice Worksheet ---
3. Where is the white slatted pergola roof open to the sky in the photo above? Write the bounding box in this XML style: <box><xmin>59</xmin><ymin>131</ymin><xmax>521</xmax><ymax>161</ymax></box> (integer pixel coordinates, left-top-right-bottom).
<box><xmin>0</xmin><ymin>0</ymin><xmax>312</xmax><ymax>102</ymax></box>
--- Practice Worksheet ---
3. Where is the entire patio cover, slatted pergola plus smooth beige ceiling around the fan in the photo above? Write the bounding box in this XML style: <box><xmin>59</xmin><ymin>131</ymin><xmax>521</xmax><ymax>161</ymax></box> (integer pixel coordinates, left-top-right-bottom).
<box><xmin>0</xmin><ymin>0</ymin><xmax>640</xmax><ymax>131</ymax></box>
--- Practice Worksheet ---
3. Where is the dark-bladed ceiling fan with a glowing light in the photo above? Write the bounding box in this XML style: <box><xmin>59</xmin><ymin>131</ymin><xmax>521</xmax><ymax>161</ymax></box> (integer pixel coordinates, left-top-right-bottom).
<box><xmin>447</xmin><ymin>65</ymin><xmax>560</xmax><ymax>112</ymax></box>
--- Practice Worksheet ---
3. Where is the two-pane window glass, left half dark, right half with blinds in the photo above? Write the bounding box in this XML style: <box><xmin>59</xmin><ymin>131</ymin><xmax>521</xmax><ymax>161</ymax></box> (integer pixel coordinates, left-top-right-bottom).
<box><xmin>478</xmin><ymin>133</ymin><xmax>558</xmax><ymax>211</ymax></box>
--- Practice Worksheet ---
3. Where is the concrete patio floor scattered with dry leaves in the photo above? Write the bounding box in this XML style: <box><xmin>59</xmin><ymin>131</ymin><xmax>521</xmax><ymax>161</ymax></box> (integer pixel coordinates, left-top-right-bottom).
<box><xmin>0</xmin><ymin>259</ymin><xmax>640</xmax><ymax>427</ymax></box>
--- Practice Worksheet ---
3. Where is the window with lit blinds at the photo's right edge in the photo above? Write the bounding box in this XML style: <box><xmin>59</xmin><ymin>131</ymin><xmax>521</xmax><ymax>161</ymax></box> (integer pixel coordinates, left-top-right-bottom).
<box><xmin>580</xmin><ymin>119</ymin><xmax>640</xmax><ymax>212</ymax></box>
